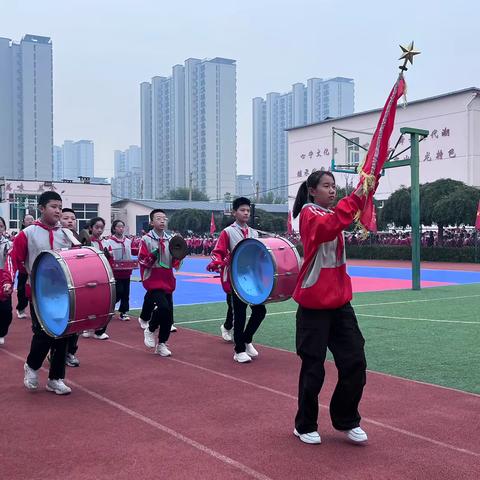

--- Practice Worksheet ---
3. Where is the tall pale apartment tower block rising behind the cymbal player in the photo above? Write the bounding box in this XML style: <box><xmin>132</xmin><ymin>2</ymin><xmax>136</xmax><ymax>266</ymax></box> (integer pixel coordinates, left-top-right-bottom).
<box><xmin>140</xmin><ymin>58</ymin><xmax>236</xmax><ymax>200</ymax></box>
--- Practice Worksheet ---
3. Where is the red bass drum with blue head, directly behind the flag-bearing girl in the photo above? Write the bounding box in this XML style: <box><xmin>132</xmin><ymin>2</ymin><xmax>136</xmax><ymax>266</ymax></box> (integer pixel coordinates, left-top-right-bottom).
<box><xmin>230</xmin><ymin>237</ymin><xmax>300</xmax><ymax>305</ymax></box>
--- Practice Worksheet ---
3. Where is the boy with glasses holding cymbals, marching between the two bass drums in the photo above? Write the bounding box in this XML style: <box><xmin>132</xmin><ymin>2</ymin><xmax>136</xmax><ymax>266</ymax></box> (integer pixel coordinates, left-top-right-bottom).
<box><xmin>138</xmin><ymin>209</ymin><xmax>180</xmax><ymax>357</ymax></box>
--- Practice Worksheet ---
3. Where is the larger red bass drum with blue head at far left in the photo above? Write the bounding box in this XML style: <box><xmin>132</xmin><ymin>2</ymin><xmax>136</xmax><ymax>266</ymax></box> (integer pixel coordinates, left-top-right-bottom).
<box><xmin>31</xmin><ymin>247</ymin><xmax>115</xmax><ymax>337</ymax></box>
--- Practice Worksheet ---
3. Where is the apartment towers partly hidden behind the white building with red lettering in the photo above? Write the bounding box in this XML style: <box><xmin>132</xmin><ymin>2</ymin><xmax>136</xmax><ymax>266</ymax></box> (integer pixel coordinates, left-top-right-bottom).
<box><xmin>253</xmin><ymin>77</ymin><xmax>354</xmax><ymax>200</ymax></box>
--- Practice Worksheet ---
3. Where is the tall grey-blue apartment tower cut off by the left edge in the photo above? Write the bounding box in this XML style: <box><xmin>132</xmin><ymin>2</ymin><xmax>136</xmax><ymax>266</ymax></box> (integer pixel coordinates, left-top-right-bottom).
<box><xmin>0</xmin><ymin>35</ymin><xmax>53</xmax><ymax>180</ymax></box>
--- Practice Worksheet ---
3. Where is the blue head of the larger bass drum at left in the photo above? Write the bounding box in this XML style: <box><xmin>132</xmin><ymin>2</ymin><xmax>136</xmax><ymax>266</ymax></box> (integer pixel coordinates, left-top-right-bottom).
<box><xmin>32</xmin><ymin>253</ymin><xmax>70</xmax><ymax>337</ymax></box>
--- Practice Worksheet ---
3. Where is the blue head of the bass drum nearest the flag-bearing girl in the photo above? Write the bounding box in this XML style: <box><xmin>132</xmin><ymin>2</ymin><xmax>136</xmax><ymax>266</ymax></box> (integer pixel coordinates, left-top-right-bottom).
<box><xmin>230</xmin><ymin>238</ymin><xmax>275</xmax><ymax>305</ymax></box>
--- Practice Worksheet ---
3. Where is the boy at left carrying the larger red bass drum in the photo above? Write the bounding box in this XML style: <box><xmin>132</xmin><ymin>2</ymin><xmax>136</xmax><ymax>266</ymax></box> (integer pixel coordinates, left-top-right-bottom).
<box><xmin>3</xmin><ymin>191</ymin><xmax>72</xmax><ymax>395</ymax></box>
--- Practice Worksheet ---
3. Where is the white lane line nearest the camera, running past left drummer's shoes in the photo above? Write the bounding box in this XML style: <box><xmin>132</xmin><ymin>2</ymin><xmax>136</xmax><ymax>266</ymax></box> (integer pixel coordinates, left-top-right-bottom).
<box><xmin>0</xmin><ymin>348</ymin><xmax>272</xmax><ymax>480</ymax></box>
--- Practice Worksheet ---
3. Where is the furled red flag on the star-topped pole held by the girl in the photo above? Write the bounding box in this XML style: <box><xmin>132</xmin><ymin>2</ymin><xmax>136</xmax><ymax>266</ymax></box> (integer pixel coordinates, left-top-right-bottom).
<box><xmin>360</xmin><ymin>74</ymin><xmax>405</xmax><ymax>232</ymax></box>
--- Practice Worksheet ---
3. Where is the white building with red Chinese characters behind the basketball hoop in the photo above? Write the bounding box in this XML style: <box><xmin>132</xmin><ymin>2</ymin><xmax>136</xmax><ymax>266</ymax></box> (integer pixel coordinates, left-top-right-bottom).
<box><xmin>288</xmin><ymin>87</ymin><xmax>480</xmax><ymax>229</ymax></box>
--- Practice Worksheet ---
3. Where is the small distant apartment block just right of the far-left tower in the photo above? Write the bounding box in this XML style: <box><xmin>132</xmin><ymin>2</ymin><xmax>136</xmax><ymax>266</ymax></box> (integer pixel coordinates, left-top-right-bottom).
<box><xmin>53</xmin><ymin>140</ymin><xmax>95</xmax><ymax>181</ymax></box>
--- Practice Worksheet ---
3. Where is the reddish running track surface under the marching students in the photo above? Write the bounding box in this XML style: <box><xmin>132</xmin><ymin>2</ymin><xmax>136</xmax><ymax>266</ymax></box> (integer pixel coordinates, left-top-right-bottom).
<box><xmin>0</xmin><ymin>319</ymin><xmax>480</xmax><ymax>480</ymax></box>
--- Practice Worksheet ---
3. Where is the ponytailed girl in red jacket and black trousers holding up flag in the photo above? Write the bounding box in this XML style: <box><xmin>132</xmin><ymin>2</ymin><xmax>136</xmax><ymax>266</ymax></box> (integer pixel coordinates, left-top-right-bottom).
<box><xmin>293</xmin><ymin>171</ymin><xmax>368</xmax><ymax>444</ymax></box>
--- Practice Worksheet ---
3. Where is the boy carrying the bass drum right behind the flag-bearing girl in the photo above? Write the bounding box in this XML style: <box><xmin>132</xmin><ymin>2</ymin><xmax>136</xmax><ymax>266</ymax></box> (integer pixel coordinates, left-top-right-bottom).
<box><xmin>207</xmin><ymin>197</ymin><xmax>267</xmax><ymax>363</ymax></box>
